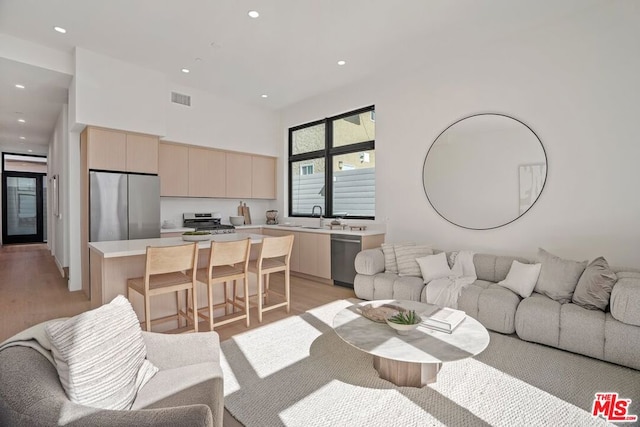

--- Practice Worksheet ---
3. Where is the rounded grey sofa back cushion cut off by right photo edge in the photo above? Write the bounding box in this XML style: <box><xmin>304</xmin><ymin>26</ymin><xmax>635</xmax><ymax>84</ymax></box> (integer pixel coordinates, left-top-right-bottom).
<box><xmin>610</xmin><ymin>272</ymin><xmax>640</xmax><ymax>326</ymax></box>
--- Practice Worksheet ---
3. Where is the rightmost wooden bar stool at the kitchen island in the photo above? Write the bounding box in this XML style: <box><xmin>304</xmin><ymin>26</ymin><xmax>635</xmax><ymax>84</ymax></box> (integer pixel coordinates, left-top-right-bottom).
<box><xmin>248</xmin><ymin>234</ymin><xmax>294</xmax><ymax>323</ymax></box>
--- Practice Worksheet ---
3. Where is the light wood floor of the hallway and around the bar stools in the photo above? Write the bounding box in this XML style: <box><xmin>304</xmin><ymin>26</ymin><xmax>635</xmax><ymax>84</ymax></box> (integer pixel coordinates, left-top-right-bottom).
<box><xmin>0</xmin><ymin>244</ymin><xmax>355</xmax><ymax>342</ymax></box>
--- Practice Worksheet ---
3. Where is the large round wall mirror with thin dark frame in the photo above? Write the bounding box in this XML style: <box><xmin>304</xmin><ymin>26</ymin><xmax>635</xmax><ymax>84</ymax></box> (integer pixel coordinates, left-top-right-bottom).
<box><xmin>422</xmin><ymin>114</ymin><xmax>547</xmax><ymax>230</ymax></box>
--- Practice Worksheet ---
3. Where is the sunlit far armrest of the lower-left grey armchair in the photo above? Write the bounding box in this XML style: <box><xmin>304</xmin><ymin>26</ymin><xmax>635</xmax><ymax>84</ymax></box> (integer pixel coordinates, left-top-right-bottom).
<box><xmin>142</xmin><ymin>331</ymin><xmax>220</xmax><ymax>369</ymax></box>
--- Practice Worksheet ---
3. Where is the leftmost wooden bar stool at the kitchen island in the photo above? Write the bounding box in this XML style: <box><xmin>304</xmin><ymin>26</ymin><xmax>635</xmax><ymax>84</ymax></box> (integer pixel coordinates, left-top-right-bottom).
<box><xmin>127</xmin><ymin>242</ymin><xmax>198</xmax><ymax>332</ymax></box>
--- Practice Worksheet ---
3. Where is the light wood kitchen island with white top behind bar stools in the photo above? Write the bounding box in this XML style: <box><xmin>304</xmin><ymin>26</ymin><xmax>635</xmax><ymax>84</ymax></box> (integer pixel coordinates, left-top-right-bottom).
<box><xmin>89</xmin><ymin>233</ymin><xmax>264</xmax><ymax>330</ymax></box>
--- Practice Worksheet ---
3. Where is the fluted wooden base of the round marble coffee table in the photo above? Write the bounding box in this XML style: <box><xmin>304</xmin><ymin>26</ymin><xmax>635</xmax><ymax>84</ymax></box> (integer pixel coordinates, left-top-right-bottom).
<box><xmin>373</xmin><ymin>356</ymin><xmax>442</xmax><ymax>387</ymax></box>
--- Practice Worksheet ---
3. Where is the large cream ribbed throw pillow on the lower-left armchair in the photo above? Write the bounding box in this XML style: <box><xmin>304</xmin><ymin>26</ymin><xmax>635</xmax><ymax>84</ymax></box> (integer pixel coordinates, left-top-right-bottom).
<box><xmin>46</xmin><ymin>295</ymin><xmax>158</xmax><ymax>409</ymax></box>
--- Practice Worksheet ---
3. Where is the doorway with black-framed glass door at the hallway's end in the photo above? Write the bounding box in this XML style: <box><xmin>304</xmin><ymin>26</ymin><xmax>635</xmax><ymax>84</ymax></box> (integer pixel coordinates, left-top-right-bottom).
<box><xmin>2</xmin><ymin>153</ymin><xmax>47</xmax><ymax>244</ymax></box>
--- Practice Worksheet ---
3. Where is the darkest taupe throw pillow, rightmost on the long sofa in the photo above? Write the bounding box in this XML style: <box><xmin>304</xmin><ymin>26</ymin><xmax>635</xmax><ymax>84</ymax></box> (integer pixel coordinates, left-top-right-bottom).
<box><xmin>571</xmin><ymin>257</ymin><xmax>618</xmax><ymax>311</ymax></box>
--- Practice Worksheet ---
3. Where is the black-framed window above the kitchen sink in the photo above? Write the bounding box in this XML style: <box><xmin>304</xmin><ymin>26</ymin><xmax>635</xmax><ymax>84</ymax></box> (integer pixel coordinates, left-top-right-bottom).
<box><xmin>289</xmin><ymin>106</ymin><xmax>376</xmax><ymax>219</ymax></box>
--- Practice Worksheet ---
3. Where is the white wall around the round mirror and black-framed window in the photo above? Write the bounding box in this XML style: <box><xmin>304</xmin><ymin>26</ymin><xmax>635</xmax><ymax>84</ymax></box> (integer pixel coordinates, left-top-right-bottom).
<box><xmin>282</xmin><ymin>2</ymin><xmax>640</xmax><ymax>266</ymax></box>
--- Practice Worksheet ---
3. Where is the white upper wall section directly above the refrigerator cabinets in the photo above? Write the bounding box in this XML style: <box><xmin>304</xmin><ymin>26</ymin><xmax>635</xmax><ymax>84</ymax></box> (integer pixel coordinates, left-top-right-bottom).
<box><xmin>70</xmin><ymin>48</ymin><xmax>169</xmax><ymax>135</ymax></box>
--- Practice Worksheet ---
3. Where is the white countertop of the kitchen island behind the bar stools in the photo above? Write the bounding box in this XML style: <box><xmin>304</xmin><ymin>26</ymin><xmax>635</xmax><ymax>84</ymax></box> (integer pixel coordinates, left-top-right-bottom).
<box><xmin>89</xmin><ymin>233</ymin><xmax>265</xmax><ymax>258</ymax></box>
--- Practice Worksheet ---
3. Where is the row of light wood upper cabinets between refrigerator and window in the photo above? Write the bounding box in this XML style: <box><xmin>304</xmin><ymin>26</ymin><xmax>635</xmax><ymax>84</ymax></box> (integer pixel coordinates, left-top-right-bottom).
<box><xmin>158</xmin><ymin>142</ymin><xmax>277</xmax><ymax>199</ymax></box>
